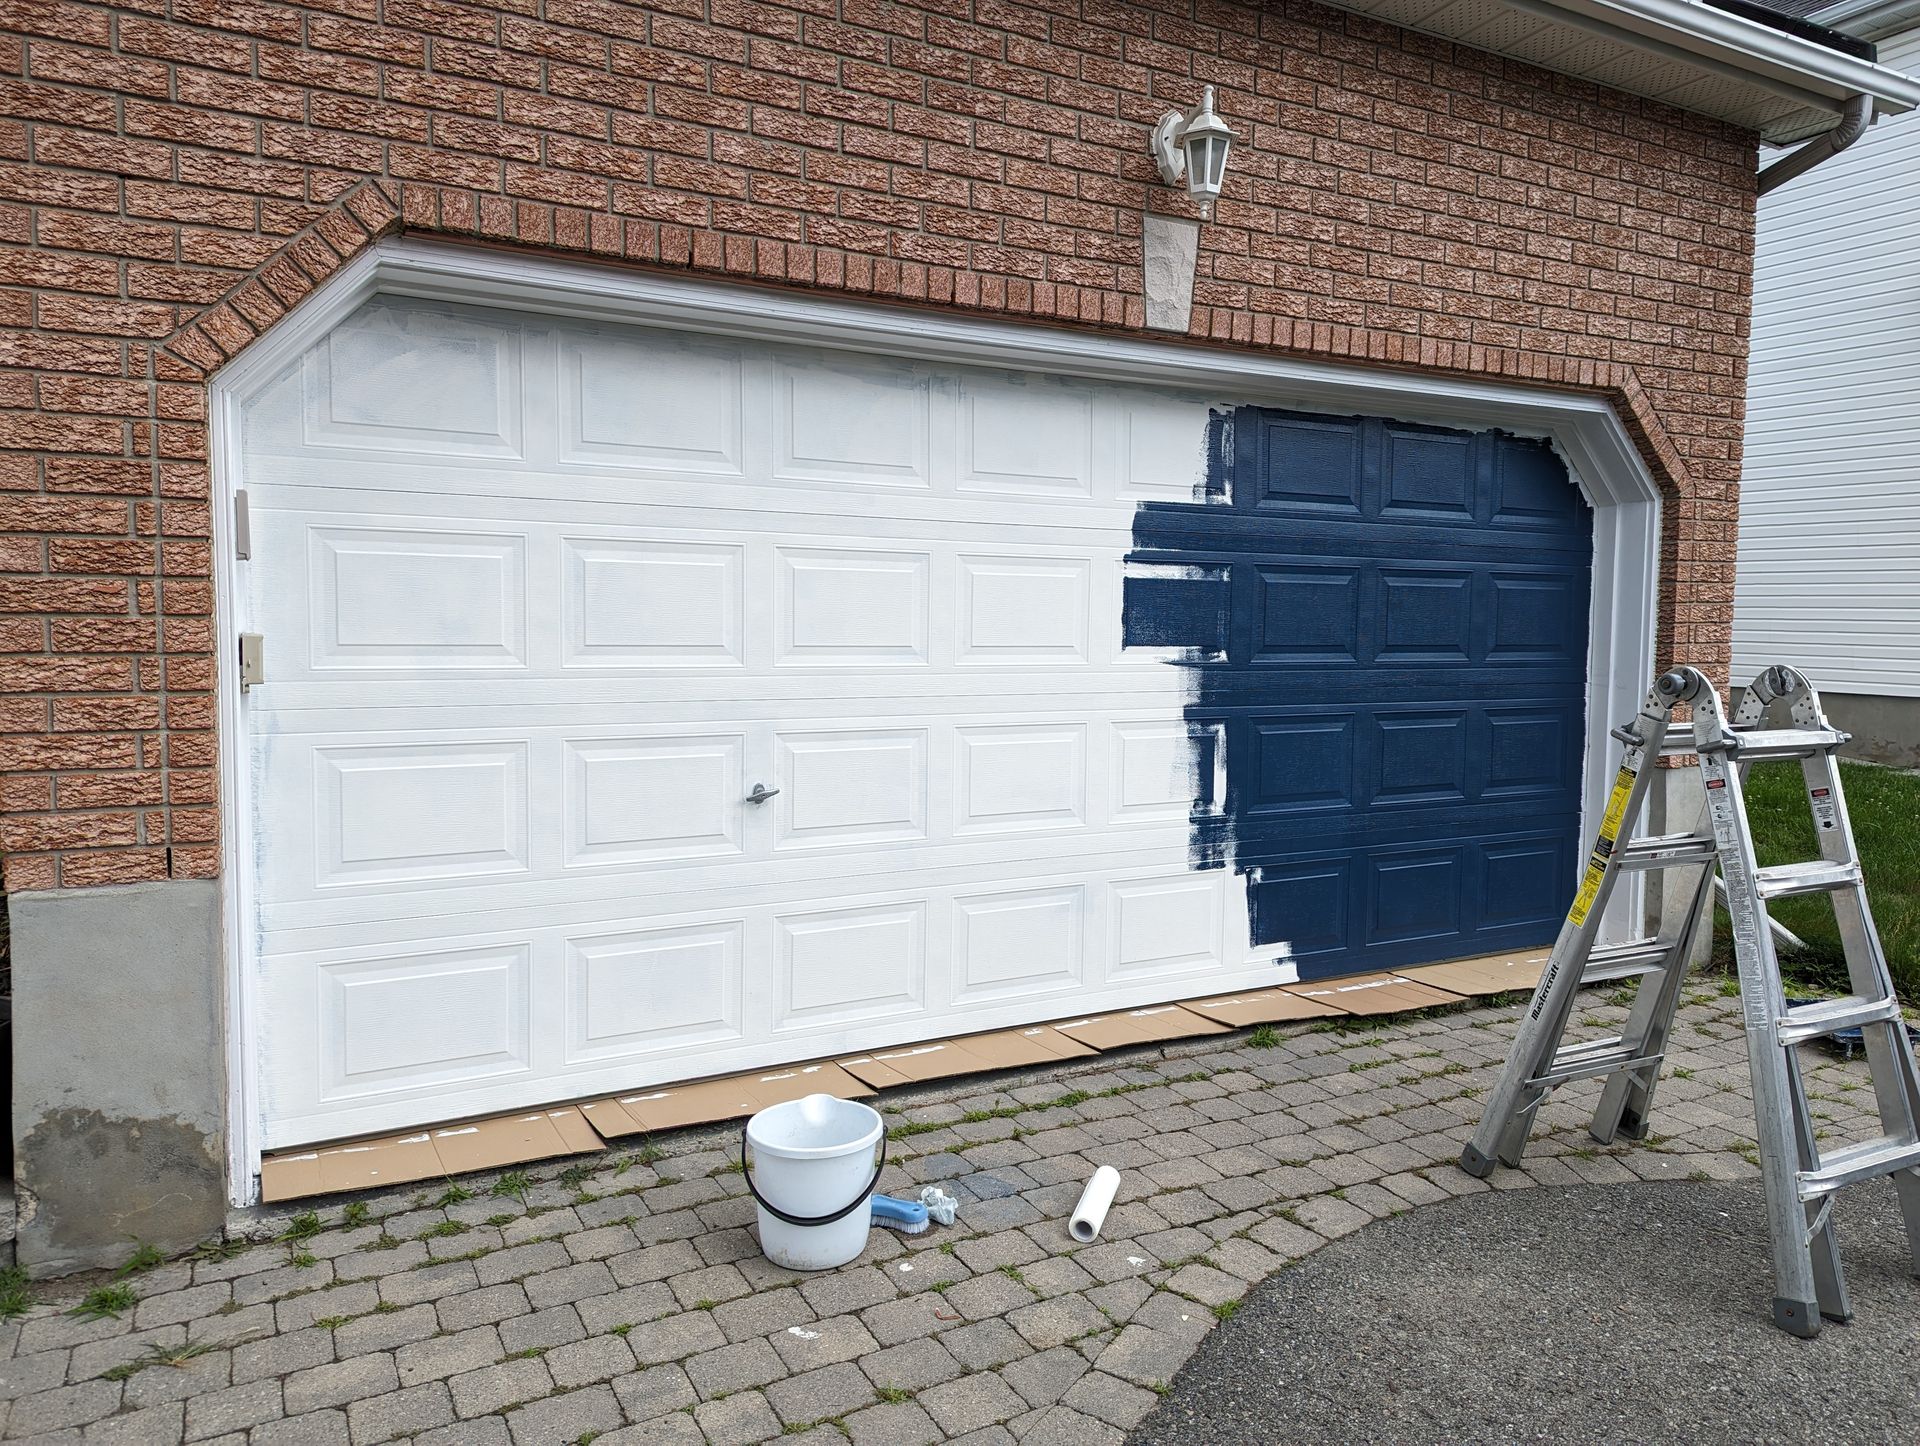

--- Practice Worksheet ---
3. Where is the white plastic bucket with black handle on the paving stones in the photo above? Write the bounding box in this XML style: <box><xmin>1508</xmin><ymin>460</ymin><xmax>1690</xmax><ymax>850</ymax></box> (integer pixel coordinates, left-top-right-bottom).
<box><xmin>739</xmin><ymin>1095</ymin><xmax>887</xmax><ymax>1269</ymax></box>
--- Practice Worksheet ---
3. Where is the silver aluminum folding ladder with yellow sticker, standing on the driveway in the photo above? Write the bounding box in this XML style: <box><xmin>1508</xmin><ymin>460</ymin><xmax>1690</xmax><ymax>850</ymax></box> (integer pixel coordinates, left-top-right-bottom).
<box><xmin>1459</xmin><ymin>668</ymin><xmax>1920</xmax><ymax>1337</ymax></box>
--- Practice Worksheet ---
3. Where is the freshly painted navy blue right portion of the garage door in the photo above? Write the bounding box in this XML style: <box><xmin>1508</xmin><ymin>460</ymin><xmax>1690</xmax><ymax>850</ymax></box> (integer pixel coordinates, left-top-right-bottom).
<box><xmin>1123</xmin><ymin>407</ymin><xmax>1594</xmax><ymax>979</ymax></box>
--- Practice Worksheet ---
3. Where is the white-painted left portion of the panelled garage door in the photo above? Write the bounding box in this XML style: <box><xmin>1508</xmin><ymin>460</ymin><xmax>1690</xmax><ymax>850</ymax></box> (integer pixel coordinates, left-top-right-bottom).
<box><xmin>234</xmin><ymin>300</ymin><xmax>1288</xmax><ymax>1146</ymax></box>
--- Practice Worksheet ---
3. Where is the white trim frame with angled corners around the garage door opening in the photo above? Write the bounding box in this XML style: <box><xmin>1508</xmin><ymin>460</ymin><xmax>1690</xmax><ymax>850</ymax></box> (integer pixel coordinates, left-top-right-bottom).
<box><xmin>209</xmin><ymin>238</ymin><xmax>1661</xmax><ymax>1204</ymax></box>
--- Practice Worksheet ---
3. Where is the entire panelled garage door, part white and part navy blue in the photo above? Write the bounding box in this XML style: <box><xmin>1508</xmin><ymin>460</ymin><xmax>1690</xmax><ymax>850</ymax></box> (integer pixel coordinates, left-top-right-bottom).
<box><xmin>236</xmin><ymin>300</ymin><xmax>1586</xmax><ymax>1146</ymax></box>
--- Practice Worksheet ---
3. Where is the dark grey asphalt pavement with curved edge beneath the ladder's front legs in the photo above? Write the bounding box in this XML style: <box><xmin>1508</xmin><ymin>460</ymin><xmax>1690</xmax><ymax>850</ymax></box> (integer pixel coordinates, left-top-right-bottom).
<box><xmin>1127</xmin><ymin>1181</ymin><xmax>1920</xmax><ymax>1446</ymax></box>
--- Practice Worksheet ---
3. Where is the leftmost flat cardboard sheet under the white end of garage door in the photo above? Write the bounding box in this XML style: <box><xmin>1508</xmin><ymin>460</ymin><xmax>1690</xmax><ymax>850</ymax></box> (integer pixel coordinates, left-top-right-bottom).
<box><xmin>259</xmin><ymin>1104</ymin><xmax>607</xmax><ymax>1204</ymax></box>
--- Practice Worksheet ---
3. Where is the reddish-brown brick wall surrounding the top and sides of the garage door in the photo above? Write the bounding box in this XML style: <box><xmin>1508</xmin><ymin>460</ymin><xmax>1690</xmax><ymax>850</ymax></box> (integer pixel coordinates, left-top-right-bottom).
<box><xmin>0</xmin><ymin>0</ymin><xmax>1753</xmax><ymax>891</ymax></box>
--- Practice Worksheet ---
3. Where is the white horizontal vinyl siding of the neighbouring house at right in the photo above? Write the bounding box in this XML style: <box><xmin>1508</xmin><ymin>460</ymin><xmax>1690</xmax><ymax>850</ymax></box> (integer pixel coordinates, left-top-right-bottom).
<box><xmin>1734</xmin><ymin>31</ymin><xmax>1920</xmax><ymax>697</ymax></box>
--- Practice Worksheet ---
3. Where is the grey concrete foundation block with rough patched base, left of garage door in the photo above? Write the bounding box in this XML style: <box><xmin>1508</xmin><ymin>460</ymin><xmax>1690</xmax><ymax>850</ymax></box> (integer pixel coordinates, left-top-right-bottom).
<box><xmin>8</xmin><ymin>880</ymin><xmax>227</xmax><ymax>1275</ymax></box>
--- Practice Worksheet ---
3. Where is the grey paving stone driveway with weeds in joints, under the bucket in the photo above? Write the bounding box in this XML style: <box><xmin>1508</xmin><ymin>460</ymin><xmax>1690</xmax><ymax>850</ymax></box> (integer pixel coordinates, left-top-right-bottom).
<box><xmin>0</xmin><ymin>979</ymin><xmax>1872</xmax><ymax>1446</ymax></box>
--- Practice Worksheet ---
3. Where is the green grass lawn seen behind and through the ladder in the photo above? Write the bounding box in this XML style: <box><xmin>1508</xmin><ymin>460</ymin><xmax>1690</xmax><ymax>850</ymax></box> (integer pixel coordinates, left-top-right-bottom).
<box><xmin>1715</xmin><ymin>762</ymin><xmax>1920</xmax><ymax>1004</ymax></box>
